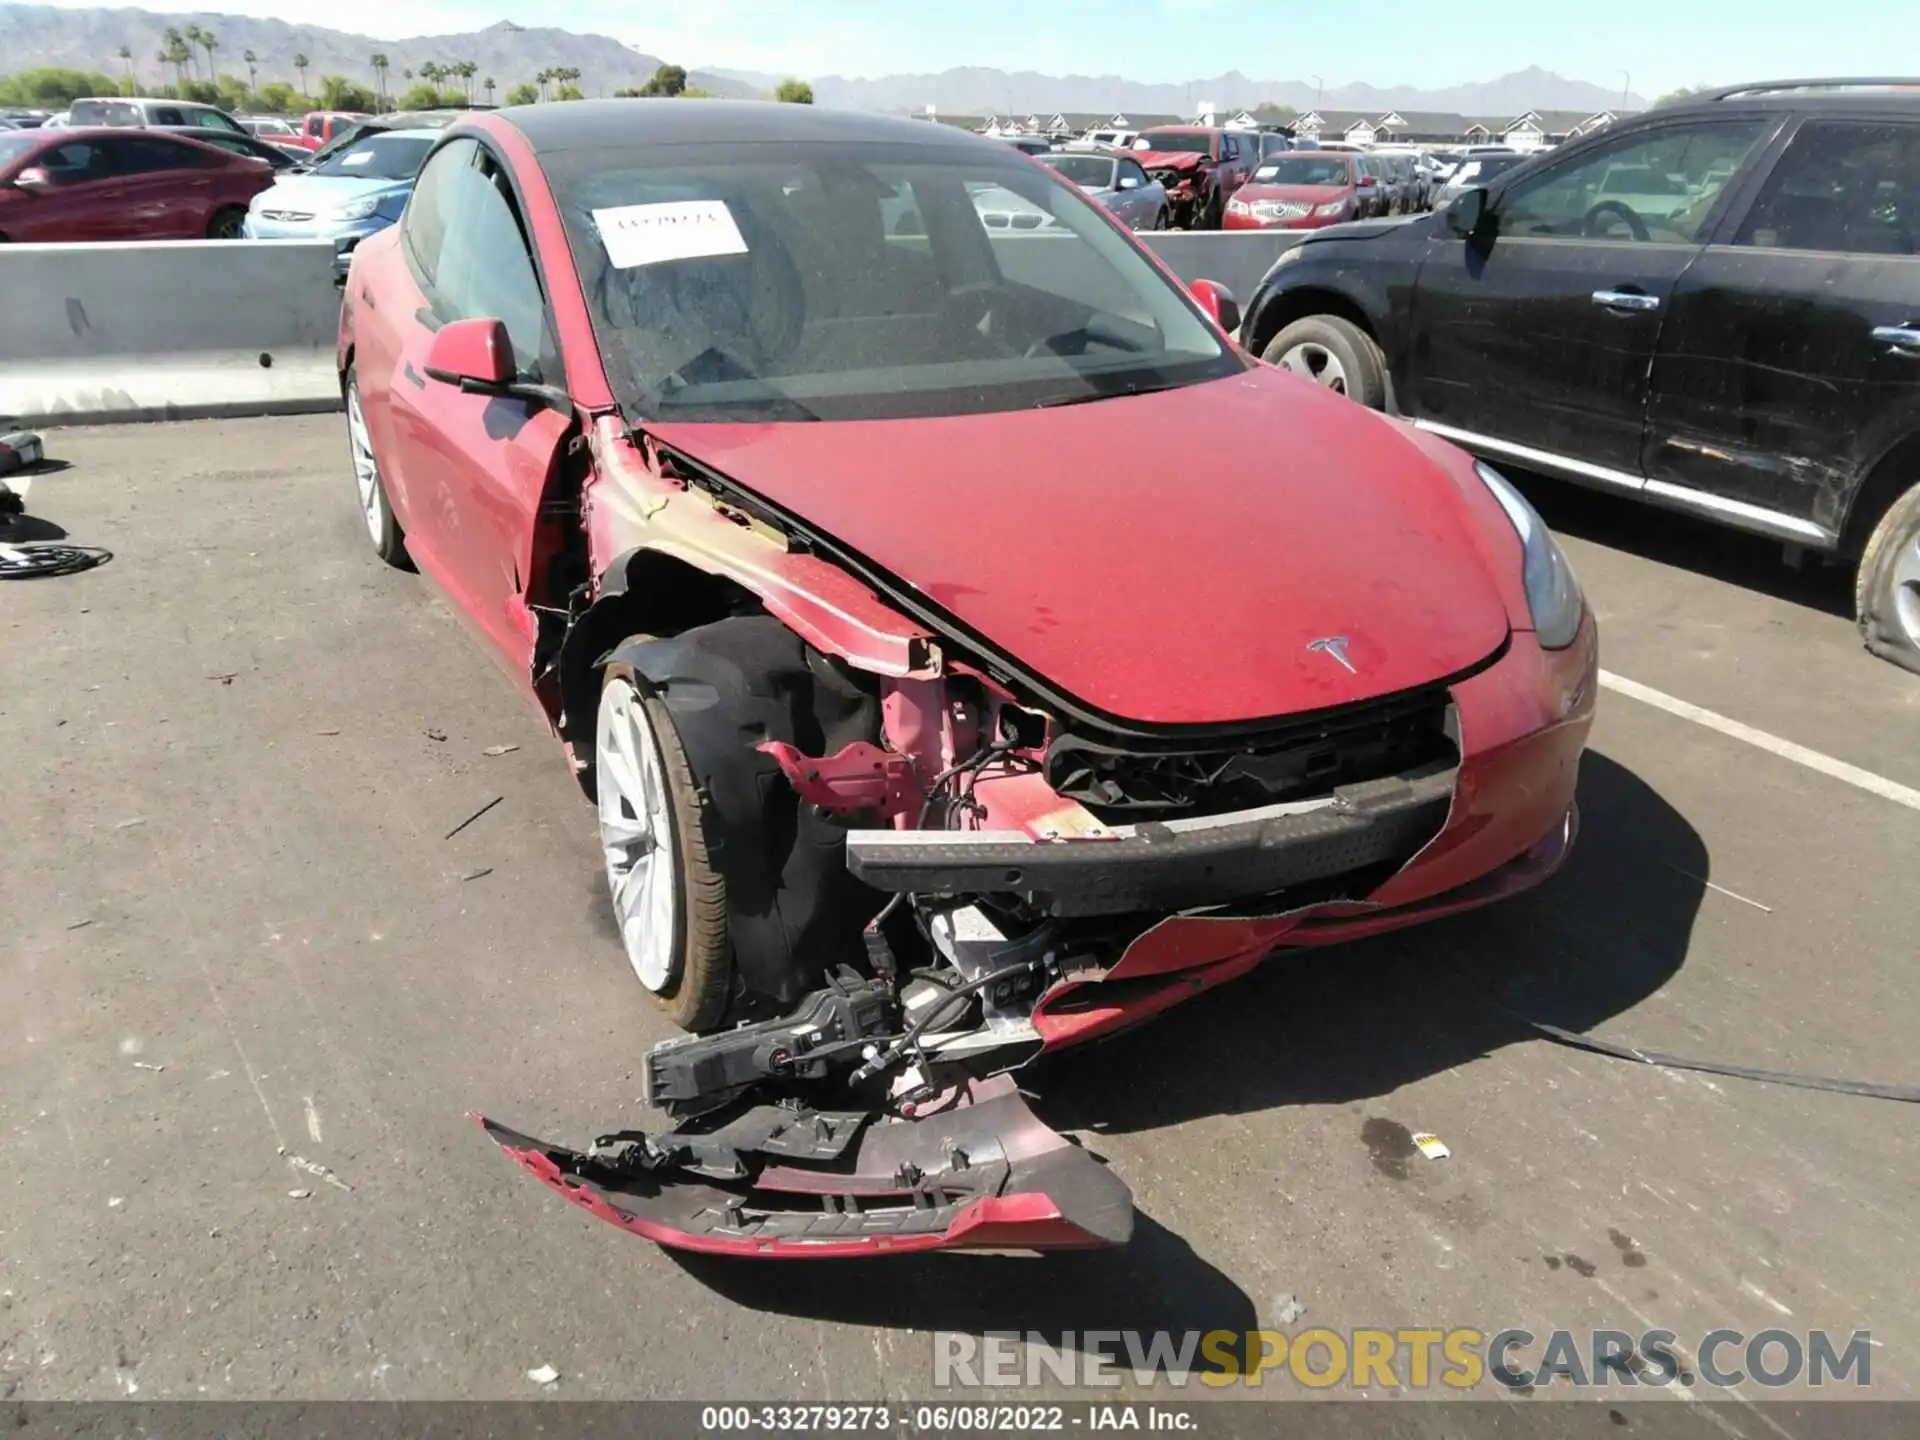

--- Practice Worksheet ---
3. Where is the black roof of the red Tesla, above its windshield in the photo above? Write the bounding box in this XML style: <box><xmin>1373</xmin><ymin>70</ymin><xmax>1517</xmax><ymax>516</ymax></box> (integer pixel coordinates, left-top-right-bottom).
<box><xmin>488</xmin><ymin>100</ymin><xmax>1004</xmax><ymax>156</ymax></box>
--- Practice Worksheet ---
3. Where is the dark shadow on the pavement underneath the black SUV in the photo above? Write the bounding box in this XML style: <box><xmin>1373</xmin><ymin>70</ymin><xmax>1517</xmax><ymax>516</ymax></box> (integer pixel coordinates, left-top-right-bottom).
<box><xmin>1509</xmin><ymin>470</ymin><xmax>1853</xmax><ymax>618</ymax></box>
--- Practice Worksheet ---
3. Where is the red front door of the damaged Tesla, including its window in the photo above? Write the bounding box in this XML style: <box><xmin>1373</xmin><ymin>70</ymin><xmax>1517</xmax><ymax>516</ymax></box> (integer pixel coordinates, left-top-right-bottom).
<box><xmin>367</xmin><ymin>142</ymin><xmax>572</xmax><ymax>685</ymax></box>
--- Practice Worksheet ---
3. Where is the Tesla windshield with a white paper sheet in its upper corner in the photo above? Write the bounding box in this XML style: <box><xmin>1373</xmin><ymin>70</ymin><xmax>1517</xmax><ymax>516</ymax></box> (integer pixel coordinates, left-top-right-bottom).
<box><xmin>547</xmin><ymin>144</ymin><xmax>1240</xmax><ymax>420</ymax></box>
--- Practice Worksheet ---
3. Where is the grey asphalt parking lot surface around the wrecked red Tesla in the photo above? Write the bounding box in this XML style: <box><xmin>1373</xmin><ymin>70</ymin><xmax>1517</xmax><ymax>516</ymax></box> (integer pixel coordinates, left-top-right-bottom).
<box><xmin>0</xmin><ymin>417</ymin><xmax>1920</xmax><ymax>1434</ymax></box>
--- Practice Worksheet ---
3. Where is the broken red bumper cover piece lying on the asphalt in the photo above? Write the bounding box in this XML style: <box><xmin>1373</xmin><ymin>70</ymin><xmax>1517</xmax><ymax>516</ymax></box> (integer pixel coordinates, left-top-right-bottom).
<box><xmin>480</xmin><ymin>1075</ymin><xmax>1133</xmax><ymax>1260</ymax></box>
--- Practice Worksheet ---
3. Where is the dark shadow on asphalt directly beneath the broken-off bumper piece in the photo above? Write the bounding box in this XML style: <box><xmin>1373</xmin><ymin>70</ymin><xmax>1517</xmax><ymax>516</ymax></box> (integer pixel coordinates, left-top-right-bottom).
<box><xmin>666</xmin><ymin>1210</ymin><xmax>1260</xmax><ymax>1359</ymax></box>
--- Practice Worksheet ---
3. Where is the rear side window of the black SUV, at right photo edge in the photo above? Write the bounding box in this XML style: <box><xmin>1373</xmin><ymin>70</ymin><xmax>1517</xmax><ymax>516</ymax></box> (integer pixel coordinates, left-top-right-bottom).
<box><xmin>1734</xmin><ymin>121</ymin><xmax>1920</xmax><ymax>255</ymax></box>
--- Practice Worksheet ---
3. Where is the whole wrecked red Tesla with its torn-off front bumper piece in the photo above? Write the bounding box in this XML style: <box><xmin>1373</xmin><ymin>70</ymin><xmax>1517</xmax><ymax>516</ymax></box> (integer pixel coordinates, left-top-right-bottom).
<box><xmin>340</xmin><ymin>100</ymin><xmax>1596</xmax><ymax>1256</ymax></box>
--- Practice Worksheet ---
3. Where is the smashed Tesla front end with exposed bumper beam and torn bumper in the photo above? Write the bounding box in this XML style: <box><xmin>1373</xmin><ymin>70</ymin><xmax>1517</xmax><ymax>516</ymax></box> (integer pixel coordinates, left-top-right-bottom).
<box><xmin>482</xmin><ymin>414</ymin><xmax>1590</xmax><ymax>1258</ymax></box>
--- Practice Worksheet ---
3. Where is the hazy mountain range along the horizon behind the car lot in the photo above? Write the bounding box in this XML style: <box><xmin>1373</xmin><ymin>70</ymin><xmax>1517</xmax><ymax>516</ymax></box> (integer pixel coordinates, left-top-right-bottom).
<box><xmin>0</xmin><ymin>4</ymin><xmax>1645</xmax><ymax>115</ymax></box>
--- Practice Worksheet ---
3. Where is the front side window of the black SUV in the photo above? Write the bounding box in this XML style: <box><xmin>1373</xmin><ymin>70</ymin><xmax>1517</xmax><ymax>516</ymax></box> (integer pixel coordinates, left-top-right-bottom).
<box><xmin>1498</xmin><ymin>117</ymin><xmax>1774</xmax><ymax>244</ymax></box>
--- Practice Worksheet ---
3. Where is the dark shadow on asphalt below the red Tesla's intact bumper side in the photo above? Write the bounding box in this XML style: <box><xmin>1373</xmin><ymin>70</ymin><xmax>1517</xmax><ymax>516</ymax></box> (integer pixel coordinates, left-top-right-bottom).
<box><xmin>1021</xmin><ymin>751</ymin><xmax>1707</xmax><ymax>1135</ymax></box>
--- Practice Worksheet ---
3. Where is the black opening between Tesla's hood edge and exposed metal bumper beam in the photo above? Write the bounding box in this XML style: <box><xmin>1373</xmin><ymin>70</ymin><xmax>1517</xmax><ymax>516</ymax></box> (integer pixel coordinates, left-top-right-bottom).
<box><xmin>1046</xmin><ymin>685</ymin><xmax>1459</xmax><ymax>824</ymax></box>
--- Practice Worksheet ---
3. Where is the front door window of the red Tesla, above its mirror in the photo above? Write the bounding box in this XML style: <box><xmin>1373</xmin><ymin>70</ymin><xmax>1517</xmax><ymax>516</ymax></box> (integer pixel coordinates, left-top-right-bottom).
<box><xmin>434</xmin><ymin>156</ymin><xmax>547</xmax><ymax>374</ymax></box>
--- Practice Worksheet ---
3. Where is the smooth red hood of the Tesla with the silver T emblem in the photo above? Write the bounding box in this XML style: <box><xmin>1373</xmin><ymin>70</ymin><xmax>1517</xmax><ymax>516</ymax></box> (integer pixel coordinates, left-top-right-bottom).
<box><xmin>649</xmin><ymin>367</ymin><xmax>1507</xmax><ymax>724</ymax></box>
